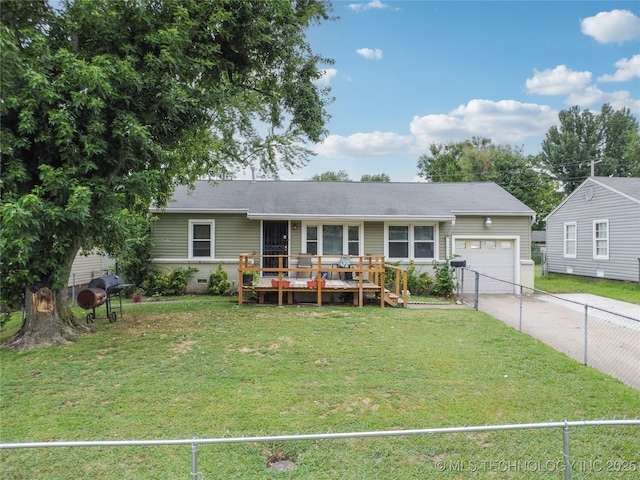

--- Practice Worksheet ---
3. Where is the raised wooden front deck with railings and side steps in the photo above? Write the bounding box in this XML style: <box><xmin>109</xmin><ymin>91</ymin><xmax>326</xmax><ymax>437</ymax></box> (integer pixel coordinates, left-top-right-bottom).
<box><xmin>238</xmin><ymin>254</ymin><xmax>407</xmax><ymax>307</ymax></box>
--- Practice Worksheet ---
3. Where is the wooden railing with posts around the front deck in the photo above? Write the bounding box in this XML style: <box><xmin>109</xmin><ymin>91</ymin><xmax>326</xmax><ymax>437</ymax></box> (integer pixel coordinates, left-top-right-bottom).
<box><xmin>238</xmin><ymin>253</ymin><xmax>407</xmax><ymax>307</ymax></box>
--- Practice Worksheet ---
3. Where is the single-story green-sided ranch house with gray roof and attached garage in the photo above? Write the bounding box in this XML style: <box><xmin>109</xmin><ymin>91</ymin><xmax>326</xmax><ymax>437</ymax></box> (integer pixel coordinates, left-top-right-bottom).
<box><xmin>151</xmin><ymin>180</ymin><xmax>535</xmax><ymax>293</ymax></box>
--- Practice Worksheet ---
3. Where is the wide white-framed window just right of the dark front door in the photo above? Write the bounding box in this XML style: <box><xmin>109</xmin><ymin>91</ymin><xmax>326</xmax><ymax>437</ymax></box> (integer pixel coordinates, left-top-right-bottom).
<box><xmin>302</xmin><ymin>223</ymin><xmax>362</xmax><ymax>256</ymax></box>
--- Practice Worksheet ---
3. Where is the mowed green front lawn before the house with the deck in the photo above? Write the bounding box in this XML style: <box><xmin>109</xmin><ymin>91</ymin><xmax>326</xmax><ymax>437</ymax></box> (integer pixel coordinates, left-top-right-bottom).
<box><xmin>0</xmin><ymin>297</ymin><xmax>640</xmax><ymax>478</ymax></box>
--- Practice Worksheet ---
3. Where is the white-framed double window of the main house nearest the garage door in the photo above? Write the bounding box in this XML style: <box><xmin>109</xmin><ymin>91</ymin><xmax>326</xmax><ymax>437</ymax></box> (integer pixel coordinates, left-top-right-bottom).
<box><xmin>385</xmin><ymin>225</ymin><xmax>436</xmax><ymax>260</ymax></box>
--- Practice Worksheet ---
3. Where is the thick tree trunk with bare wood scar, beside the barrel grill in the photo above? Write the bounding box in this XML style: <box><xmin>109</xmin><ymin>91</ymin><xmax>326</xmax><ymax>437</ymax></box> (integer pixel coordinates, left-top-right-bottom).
<box><xmin>4</xmin><ymin>284</ymin><xmax>78</xmax><ymax>351</ymax></box>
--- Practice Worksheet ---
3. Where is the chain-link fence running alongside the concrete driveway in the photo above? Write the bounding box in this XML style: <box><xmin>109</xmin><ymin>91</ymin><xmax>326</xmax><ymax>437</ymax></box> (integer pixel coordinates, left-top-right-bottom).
<box><xmin>461</xmin><ymin>269</ymin><xmax>640</xmax><ymax>390</ymax></box>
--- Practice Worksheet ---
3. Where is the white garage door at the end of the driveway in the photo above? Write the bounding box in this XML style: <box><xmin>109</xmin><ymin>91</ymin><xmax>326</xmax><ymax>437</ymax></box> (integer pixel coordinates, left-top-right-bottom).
<box><xmin>455</xmin><ymin>239</ymin><xmax>516</xmax><ymax>293</ymax></box>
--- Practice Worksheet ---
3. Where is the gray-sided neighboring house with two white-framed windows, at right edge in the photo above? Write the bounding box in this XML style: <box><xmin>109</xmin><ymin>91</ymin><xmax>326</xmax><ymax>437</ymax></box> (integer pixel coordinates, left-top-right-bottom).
<box><xmin>546</xmin><ymin>177</ymin><xmax>640</xmax><ymax>281</ymax></box>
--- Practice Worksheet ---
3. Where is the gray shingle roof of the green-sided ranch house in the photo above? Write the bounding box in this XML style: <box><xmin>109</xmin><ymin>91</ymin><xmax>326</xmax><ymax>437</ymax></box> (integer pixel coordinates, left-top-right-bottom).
<box><xmin>160</xmin><ymin>180</ymin><xmax>535</xmax><ymax>220</ymax></box>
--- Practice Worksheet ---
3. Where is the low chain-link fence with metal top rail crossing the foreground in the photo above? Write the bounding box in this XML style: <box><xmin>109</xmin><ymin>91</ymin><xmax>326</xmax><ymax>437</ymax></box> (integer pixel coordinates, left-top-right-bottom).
<box><xmin>0</xmin><ymin>419</ymin><xmax>640</xmax><ymax>480</ymax></box>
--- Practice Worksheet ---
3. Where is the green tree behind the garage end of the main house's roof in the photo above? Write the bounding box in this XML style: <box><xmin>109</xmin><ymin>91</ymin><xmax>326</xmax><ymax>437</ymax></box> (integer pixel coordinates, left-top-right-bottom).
<box><xmin>418</xmin><ymin>137</ymin><xmax>560</xmax><ymax>230</ymax></box>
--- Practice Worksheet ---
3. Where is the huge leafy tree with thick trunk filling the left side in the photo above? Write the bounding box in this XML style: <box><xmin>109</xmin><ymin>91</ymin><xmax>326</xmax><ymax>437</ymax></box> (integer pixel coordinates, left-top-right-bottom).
<box><xmin>0</xmin><ymin>0</ymin><xmax>330</xmax><ymax>349</ymax></box>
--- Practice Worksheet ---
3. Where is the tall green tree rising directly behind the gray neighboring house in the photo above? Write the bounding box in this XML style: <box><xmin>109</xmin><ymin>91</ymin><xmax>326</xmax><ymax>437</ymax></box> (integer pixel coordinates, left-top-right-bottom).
<box><xmin>541</xmin><ymin>104</ymin><xmax>640</xmax><ymax>194</ymax></box>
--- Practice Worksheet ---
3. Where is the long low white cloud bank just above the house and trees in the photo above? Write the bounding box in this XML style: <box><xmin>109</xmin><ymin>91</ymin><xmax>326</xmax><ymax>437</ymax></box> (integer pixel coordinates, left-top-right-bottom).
<box><xmin>315</xmin><ymin>100</ymin><xmax>558</xmax><ymax>158</ymax></box>
